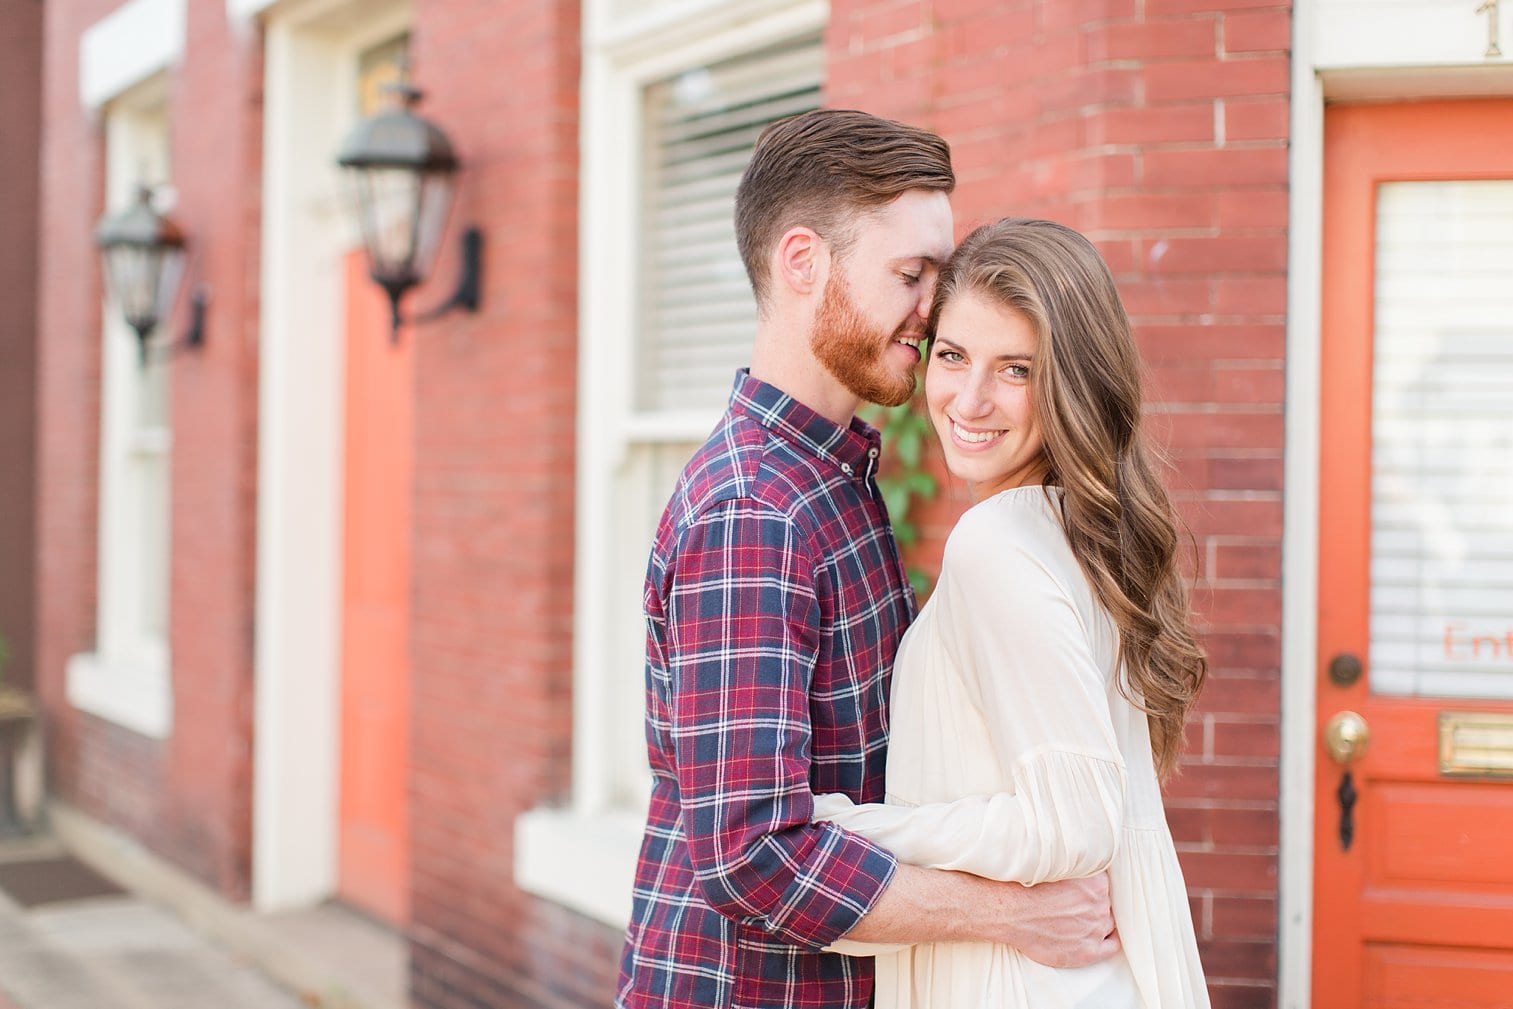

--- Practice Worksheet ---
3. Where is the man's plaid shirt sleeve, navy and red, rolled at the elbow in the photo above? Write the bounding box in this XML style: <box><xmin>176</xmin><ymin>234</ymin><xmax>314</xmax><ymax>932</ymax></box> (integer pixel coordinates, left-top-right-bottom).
<box><xmin>667</xmin><ymin>499</ymin><xmax>896</xmax><ymax>948</ymax></box>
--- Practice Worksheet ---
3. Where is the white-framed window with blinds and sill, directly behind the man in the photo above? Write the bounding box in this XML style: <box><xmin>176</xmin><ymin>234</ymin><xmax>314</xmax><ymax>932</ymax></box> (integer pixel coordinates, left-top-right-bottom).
<box><xmin>516</xmin><ymin>3</ymin><xmax>826</xmax><ymax>924</ymax></box>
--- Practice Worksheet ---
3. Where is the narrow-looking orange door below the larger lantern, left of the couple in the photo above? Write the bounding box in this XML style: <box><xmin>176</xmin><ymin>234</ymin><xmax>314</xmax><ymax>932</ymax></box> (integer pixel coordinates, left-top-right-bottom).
<box><xmin>337</xmin><ymin>251</ymin><xmax>412</xmax><ymax>924</ymax></box>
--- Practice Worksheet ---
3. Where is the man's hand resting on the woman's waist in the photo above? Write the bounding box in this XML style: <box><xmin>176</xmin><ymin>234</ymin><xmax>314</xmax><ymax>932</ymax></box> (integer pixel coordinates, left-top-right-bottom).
<box><xmin>983</xmin><ymin>873</ymin><xmax>1120</xmax><ymax>967</ymax></box>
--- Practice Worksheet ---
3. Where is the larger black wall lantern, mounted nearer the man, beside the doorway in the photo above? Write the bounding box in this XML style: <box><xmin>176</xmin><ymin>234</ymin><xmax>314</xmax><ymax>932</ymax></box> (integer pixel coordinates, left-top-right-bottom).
<box><xmin>337</xmin><ymin>85</ymin><xmax>483</xmax><ymax>340</ymax></box>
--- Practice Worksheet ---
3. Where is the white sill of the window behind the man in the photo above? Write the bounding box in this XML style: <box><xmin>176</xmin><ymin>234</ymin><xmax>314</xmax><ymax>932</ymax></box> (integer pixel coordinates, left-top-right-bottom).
<box><xmin>514</xmin><ymin>809</ymin><xmax>645</xmax><ymax>929</ymax></box>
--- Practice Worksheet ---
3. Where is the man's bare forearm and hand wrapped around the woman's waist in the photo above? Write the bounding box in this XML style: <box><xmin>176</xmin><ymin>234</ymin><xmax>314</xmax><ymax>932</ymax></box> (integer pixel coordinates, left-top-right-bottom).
<box><xmin>832</xmin><ymin>864</ymin><xmax>1120</xmax><ymax>967</ymax></box>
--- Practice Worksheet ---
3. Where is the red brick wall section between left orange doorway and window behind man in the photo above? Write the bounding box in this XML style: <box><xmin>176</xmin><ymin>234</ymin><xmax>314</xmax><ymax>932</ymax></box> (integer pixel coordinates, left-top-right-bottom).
<box><xmin>407</xmin><ymin>0</ymin><xmax>619</xmax><ymax>1009</ymax></box>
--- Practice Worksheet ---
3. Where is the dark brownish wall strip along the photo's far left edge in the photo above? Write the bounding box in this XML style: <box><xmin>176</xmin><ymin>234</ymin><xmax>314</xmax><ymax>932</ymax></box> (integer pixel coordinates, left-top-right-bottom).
<box><xmin>0</xmin><ymin>0</ymin><xmax>42</xmax><ymax>687</ymax></box>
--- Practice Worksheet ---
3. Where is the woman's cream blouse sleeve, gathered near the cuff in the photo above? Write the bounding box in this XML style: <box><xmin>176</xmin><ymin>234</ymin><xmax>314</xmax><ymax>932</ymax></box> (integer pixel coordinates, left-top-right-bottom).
<box><xmin>814</xmin><ymin>501</ymin><xmax>1126</xmax><ymax>883</ymax></box>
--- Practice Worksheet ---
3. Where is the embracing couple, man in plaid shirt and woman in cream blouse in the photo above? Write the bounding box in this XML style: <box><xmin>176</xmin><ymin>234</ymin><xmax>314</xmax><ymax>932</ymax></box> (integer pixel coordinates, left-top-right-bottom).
<box><xmin>616</xmin><ymin>110</ymin><xmax>1209</xmax><ymax>1009</ymax></box>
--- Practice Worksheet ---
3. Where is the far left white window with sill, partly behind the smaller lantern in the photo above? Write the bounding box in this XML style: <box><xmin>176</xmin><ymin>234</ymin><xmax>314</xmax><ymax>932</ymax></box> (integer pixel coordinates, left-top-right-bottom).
<box><xmin>68</xmin><ymin>76</ymin><xmax>172</xmax><ymax>738</ymax></box>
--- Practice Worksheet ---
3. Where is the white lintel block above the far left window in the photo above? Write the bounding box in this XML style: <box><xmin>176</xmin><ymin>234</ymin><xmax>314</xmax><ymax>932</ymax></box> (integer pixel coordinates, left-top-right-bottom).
<box><xmin>79</xmin><ymin>0</ymin><xmax>186</xmax><ymax>110</ymax></box>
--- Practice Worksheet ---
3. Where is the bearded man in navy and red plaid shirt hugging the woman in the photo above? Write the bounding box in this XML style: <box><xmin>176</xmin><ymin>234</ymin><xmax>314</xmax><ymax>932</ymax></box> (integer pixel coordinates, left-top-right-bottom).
<box><xmin>616</xmin><ymin>110</ymin><xmax>1117</xmax><ymax>1009</ymax></box>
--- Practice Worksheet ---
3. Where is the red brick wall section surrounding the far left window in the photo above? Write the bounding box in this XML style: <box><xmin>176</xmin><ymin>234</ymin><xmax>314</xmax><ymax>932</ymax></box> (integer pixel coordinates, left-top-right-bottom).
<box><xmin>38</xmin><ymin>0</ymin><xmax>262</xmax><ymax>899</ymax></box>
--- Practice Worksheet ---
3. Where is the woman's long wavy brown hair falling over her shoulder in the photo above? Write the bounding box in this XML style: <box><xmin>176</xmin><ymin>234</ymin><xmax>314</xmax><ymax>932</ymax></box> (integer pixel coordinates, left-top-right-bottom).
<box><xmin>929</xmin><ymin>218</ymin><xmax>1207</xmax><ymax>779</ymax></box>
